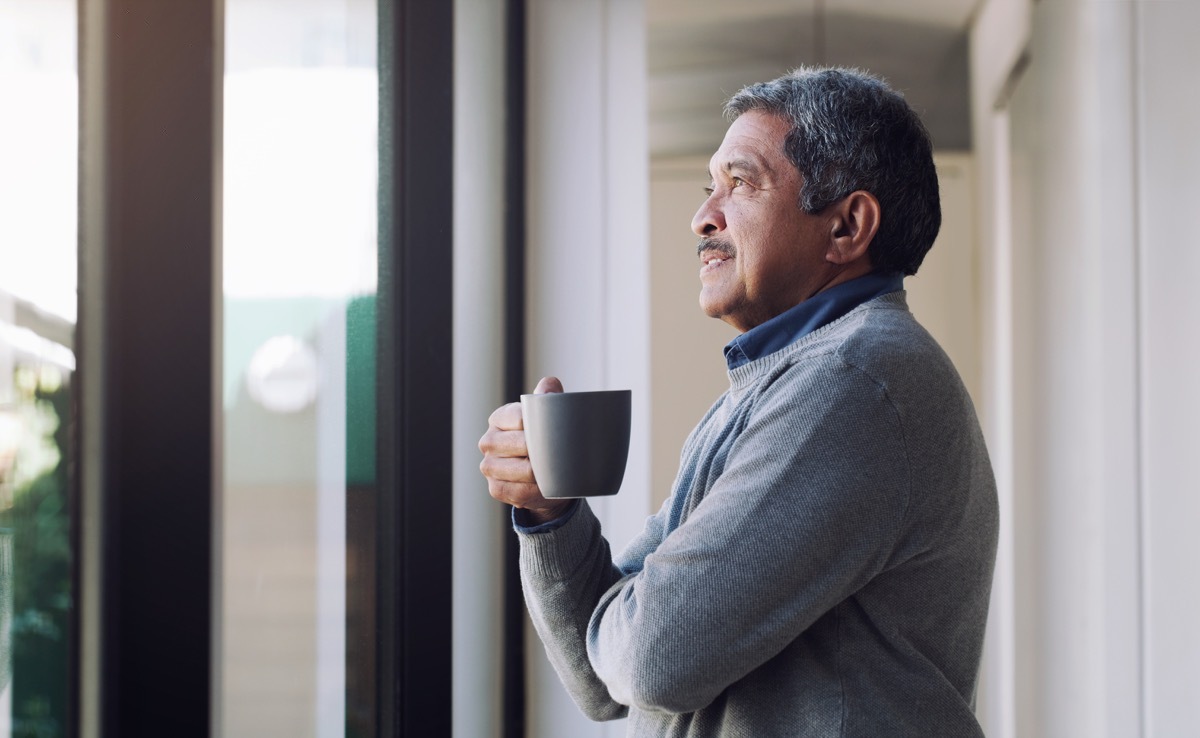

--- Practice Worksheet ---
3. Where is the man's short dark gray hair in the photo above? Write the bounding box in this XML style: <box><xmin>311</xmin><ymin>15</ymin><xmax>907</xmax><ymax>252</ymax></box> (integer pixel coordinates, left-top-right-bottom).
<box><xmin>725</xmin><ymin>67</ymin><xmax>942</xmax><ymax>275</ymax></box>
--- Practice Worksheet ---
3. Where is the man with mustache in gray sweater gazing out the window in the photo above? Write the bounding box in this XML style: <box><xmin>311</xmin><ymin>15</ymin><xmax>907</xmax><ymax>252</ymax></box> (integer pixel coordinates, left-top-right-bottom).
<box><xmin>480</xmin><ymin>68</ymin><xmax>997</xmax><ymax>738</ymax></box>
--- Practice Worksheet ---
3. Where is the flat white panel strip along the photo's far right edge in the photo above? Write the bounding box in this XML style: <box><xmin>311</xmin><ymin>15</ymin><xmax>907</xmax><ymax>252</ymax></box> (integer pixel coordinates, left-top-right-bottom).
<box><xmin>1134</xmin><ymin>2</ymin><xmax>1200</xmax><ymax>738</ymax></box>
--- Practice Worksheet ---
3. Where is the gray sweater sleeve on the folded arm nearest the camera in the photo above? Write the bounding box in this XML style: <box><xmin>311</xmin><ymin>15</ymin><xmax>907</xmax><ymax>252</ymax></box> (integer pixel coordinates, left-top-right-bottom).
<box><xmin>587</xmin><ymin>355</ymin><xmax>910</xmax><ymax>713</ymax></box>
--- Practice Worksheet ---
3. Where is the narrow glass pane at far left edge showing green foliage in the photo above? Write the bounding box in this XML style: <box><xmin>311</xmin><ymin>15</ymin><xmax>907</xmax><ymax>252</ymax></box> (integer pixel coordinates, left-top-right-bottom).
<box><xmin>0</xmin><ymin>0</ymin><xmax>78</xmax><ymax>738</ymax></box>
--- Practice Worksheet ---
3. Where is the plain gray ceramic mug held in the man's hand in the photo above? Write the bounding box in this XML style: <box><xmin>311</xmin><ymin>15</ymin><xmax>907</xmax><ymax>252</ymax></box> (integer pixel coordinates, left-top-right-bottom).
<box><xmin>521</xmin><ymin>390</ymin><xmax>632</xmax><ymax>499</ymax></box>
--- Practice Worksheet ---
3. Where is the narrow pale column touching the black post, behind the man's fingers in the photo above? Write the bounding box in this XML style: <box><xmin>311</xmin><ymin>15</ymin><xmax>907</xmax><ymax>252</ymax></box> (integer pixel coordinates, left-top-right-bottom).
<box><xmin>451</xmin><ymin>0</ymin><xmax>514</xmax><ymax>738</ymax></box>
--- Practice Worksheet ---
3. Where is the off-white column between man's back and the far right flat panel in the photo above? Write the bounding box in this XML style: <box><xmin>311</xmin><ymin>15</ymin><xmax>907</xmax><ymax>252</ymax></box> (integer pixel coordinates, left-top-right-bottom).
<box><xmin>972</xmin><ymin>0</ymin><xmax>1152</xmax><ymax>738</ymax></box>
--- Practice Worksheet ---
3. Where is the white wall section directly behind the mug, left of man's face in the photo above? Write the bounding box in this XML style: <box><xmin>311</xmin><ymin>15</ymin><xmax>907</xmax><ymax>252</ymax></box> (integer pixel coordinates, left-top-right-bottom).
<box><xmin>527</xmin><ymin>0</ymin><xmax>650</xmax><ymax>738</ymax></box>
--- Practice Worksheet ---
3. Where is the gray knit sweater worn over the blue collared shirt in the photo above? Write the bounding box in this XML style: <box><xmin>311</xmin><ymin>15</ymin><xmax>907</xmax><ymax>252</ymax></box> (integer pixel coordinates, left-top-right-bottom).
<box><xmin>521</xmin><ymin>293</ymin><xmax>997</xmax><ymax>738</ymax></box>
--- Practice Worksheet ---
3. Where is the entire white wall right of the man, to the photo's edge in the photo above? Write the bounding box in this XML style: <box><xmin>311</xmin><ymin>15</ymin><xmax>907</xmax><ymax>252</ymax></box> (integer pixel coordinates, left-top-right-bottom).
<box><xmin>972</xmin><ymin>0</ymin><xmax>1200</xmax><ymax>737</ymax></box>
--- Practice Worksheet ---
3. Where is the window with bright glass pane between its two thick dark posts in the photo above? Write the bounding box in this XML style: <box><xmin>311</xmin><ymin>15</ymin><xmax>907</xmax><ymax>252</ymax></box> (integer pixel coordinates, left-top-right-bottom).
<box><xmin>76</xmin><ymin>0</ymin><xmax>452</xmax><ymax>738</ymax></box>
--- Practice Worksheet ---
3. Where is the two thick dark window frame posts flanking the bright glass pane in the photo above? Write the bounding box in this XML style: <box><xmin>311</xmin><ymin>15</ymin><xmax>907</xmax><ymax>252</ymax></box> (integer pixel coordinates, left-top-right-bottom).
<box><xmin>77</xmin><ymin>0</ymin><xmax>454</xmax><ymax>738</ymax></box>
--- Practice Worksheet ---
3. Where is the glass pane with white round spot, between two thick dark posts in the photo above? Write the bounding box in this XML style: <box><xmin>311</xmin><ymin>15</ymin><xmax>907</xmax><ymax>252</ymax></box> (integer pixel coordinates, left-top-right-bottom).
<box><xmin>216</xmin><ymin>0</ymin><xmax>378</xmax><ymax>738</ymax></box>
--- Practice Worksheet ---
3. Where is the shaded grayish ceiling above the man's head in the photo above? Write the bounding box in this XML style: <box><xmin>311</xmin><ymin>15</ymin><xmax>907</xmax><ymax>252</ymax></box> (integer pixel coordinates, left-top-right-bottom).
<box><xmin>646</xmin><ymin>0</ymin><xmax>978</xmax><ymax>158</ymax></box>
